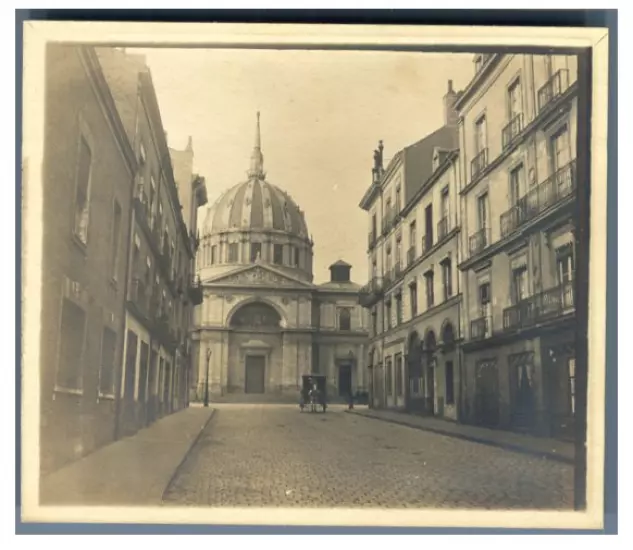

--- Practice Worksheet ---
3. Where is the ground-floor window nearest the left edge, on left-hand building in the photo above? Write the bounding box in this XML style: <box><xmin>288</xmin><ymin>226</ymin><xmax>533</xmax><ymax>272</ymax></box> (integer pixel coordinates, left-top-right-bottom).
<box><xmin>57</xmin><ymin>298</ymin><xmax>86</xmax><ymax>390</ymax></box>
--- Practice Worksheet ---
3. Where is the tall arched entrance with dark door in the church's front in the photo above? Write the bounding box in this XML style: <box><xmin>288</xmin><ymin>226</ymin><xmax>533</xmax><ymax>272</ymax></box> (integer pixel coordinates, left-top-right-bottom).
<box><xmin>227</xmin><ymin>301</ymin><xmax>283</xmax><ymax>395</ymax></box>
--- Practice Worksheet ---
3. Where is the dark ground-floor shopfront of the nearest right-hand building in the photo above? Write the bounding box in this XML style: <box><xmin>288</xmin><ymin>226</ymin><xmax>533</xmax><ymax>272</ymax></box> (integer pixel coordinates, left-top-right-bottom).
<box><xmin>462</xmin><ymin>327</ymin><xmax>576</xmax><ymax>438</ymax></box>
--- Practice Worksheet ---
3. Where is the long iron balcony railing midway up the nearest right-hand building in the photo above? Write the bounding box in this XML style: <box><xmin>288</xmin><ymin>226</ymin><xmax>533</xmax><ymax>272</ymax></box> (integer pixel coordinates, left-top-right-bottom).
<box><xmin>499</xmin><ymin>160</ymin><xmax>576</xmax><ymax>237</ymax></box>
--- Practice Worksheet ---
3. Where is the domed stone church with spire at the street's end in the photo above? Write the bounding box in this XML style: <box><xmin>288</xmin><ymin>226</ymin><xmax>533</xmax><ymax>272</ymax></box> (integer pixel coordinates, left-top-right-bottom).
<box><xmin>192</xmin><ymin>113</ymin><xmax>368</xmax><ymax>402</ymax></box>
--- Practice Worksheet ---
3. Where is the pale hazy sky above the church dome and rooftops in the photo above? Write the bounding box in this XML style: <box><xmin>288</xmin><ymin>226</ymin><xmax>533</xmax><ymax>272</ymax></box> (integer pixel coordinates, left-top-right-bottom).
<box><xmin>136</xmin><ymin>49</ymin><xmax>474</xmax><ymax>284</ymax></box>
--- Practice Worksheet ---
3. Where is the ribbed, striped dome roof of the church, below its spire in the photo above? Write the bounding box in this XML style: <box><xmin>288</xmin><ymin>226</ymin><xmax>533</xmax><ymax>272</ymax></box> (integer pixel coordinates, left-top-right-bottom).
<box><xmin>204</xmin><ymin>176</ymin><xmax>308</xmax><ymax>239</ymax></box>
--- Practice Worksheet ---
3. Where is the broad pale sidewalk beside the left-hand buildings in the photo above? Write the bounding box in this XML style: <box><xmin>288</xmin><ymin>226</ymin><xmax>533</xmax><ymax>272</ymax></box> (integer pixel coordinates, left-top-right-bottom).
<box><xmin>40</xmin><ymin>407</ymin><xmax>215</xmax><ymax>506</ymax></box>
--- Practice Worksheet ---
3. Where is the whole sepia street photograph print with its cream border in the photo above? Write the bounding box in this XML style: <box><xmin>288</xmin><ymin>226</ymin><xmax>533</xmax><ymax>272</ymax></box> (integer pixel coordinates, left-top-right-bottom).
<box><xmin>21</xmin><ymin>22</ymin><xmax>608</xmax><ymax>528</ymax></box>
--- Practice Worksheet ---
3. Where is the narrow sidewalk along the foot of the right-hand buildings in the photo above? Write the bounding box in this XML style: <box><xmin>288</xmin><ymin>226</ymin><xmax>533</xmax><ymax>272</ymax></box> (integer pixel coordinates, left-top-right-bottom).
<box><xmin>347</xmin><ymin>408</ymin><xmax>575</xmax><ymax>464</ymax></box>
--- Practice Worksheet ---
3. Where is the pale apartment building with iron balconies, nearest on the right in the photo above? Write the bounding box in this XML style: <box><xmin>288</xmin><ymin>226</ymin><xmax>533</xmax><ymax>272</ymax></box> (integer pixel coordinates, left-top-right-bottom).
<box><xmin>456</xmin><ymin>54</ymin><xmax>578</xmax><ymax>435</ymax></box>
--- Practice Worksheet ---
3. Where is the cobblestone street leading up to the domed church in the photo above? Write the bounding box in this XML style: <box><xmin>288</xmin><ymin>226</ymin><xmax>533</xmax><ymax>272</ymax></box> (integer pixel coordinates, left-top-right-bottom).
<box><xmin>164</xmin><ymin>405</ymin><xmax>573</xmax><ymax>509</ymax></box>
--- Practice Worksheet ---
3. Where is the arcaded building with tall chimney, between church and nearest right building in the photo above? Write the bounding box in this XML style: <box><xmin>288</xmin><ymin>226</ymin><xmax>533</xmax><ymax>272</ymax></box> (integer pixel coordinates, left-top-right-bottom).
<box><xmin>360</xmin><ymin>81</ymin><xmax>462</xmax><ymax>419</ymax></box>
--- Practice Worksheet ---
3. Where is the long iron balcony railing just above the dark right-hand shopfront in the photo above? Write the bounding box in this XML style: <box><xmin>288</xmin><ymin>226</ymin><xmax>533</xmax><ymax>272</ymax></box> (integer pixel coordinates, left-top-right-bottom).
<box><xmin>503</xmin><ymin>282</ymin><xmax>575</xmax><ymax>330</ymax></box>
